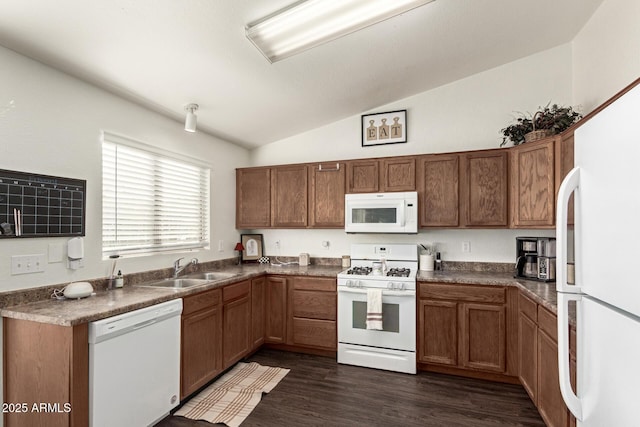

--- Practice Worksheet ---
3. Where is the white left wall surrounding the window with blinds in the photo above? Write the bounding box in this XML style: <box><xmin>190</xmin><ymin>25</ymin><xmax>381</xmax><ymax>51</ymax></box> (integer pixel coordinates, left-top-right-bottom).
<box><xmin>0</xmin><ymin>47</ymin><xmax>249</xmax><ymax>291</ymax></box>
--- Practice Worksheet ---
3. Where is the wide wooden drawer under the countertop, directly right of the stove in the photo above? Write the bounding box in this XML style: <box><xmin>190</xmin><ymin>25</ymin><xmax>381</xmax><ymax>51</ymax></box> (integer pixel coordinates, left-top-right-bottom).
<box><xmin>420</xmin><ymin>283</ymin><xmax>506</xmax><ymax>304</ymax></box>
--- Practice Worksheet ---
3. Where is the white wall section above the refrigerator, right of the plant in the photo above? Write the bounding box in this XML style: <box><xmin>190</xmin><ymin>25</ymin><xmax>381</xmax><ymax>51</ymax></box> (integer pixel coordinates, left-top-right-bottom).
<box><xmin>573</xmin><ymin>0</ymin><xmax>640</xmax><ymax>112</ymax></box>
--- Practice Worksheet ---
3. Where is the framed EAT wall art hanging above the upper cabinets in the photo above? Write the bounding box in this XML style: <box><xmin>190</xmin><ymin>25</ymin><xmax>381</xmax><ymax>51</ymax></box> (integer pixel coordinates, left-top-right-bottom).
<box><xmin>362</xmin><ymin>110</ymin><xmax>407</xmax><ymax>147</ymax></box>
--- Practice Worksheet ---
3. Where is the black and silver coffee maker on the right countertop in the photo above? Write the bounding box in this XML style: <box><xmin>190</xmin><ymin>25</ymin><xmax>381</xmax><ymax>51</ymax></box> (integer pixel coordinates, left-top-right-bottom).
<box><xmin>515</xmin><ymin>237</ymin><xmax>556</xmax><ymax>282</ymax></box>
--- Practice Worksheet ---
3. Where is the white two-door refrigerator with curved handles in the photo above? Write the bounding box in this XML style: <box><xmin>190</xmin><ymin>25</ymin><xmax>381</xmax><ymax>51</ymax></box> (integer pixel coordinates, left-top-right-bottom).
<box><xmin>556</xmin><ymin>82</ymin><xmax>640</xmax><ymax>427</ymax></box>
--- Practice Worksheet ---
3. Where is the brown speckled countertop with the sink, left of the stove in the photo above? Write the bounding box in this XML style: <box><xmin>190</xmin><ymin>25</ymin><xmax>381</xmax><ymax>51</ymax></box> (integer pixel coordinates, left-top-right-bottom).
<box><xmin>0</xmin><ymin>264</ymin><xmax>342</xmax><ymax>326</ymax></box>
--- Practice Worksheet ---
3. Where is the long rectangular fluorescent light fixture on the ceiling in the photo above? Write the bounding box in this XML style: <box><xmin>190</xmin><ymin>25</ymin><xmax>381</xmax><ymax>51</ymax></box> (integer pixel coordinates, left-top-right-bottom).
<box><xmin>245</xmin><ymin>0</ymin><xmax>434</xmax><ymax>62</ymax></box>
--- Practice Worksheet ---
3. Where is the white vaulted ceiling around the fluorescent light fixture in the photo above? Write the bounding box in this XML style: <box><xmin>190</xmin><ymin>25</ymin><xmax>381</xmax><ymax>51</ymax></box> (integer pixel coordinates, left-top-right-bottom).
<box><xmin>0</xmin><ymin>0</ymin><xmax>603</xmax><ymax>148</ymax></box>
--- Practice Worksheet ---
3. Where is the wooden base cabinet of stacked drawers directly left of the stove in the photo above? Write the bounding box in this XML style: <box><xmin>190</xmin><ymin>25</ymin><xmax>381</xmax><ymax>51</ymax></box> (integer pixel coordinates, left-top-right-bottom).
<box><xmin>287</xmin><ymin>276</ymin><xmax>338</xmax><ymax>351</ymax></box>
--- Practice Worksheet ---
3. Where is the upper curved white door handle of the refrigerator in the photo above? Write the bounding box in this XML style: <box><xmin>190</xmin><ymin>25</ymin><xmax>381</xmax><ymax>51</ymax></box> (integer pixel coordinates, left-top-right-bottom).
<box><xmin>556</xmin><ymin>167</ymin><xmax>582</xmax><ymax>293</ymax></box>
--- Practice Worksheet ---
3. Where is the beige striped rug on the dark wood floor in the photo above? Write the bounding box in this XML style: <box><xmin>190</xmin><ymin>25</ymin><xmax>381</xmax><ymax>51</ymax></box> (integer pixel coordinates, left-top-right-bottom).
<box><xmin>174</xmin><ymin>362</ymin><xmax>289</xmax><ymax>427</ymax></box>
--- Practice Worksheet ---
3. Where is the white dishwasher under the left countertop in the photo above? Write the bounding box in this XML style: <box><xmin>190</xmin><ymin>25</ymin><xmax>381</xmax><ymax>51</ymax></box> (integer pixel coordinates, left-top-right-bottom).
<box><xmin>89</xmin><ymin>299</ymin><xmax>182</xmax><ymax>427</ymax></box>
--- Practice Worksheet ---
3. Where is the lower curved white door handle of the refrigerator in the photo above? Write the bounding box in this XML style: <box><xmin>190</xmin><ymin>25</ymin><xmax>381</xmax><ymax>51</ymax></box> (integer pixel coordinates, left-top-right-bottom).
<box><xmin>558</xmin><ymin>292</ymin><xmax>582</xmax><ymax>421</ymax></box>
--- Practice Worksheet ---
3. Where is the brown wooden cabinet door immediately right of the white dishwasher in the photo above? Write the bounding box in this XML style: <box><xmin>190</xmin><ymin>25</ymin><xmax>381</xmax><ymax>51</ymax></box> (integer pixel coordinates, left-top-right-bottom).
<box><xmin>180</xmin><ymin>305</ymin><xmax>222</xmax><ymax>399</ymax></box>
